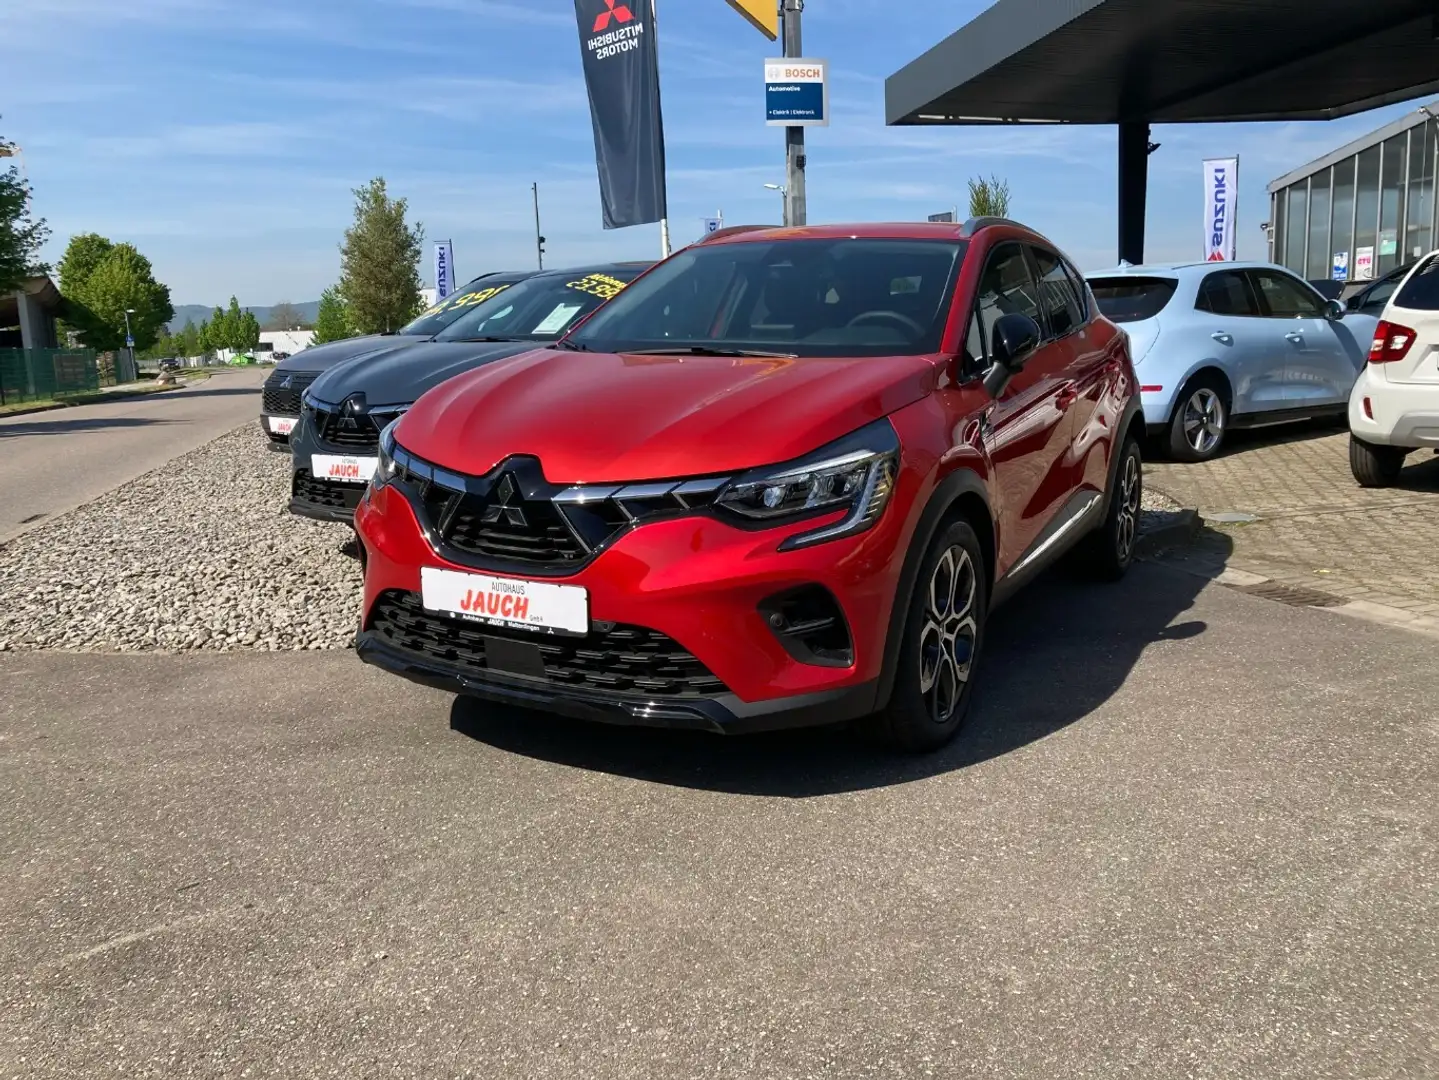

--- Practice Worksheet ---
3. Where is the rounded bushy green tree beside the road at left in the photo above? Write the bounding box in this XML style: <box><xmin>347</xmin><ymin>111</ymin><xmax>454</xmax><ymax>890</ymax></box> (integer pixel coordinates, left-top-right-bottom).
<box><xmin>60</xmin><ymin>241</ymin><xmax>176</xmax><ymax>349</ymax></box>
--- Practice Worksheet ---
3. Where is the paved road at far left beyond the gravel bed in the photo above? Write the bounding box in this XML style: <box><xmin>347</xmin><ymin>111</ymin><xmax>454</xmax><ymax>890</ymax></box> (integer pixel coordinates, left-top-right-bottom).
<box><xmin>0</xmin><ymin>367</ymin><xmax>269</xmax><ymax>541</ymax></box>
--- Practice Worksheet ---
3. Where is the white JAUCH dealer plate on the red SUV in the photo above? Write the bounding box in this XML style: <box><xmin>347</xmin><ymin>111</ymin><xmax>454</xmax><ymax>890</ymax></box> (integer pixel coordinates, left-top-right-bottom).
<box><xmin>420</xmin><ymin>567</ymin><xmax>590</xmax><ymax>634</ymax></box>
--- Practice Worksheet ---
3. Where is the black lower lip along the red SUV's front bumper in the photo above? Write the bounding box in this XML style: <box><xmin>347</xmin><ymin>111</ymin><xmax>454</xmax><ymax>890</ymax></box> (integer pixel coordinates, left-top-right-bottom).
<box><xmin>355</xmin><ymin>631</ymin><xmax>878</xmax><ymax>735</ymax></box>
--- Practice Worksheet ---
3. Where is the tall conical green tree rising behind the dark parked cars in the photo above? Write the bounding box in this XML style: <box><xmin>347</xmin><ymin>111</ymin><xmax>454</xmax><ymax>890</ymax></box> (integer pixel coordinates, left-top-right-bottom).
<box><xmin>340</xmin><ymin>177</ymin><xmax>425</xmax><ymax>334</ymax></box>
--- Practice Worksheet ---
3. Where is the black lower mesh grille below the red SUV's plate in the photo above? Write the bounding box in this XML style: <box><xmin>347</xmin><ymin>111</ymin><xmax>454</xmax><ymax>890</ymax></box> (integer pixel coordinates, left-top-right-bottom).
<box><xmin>367</xmin><ymin>590</ymin><xmax>727</xmax><ymax>700</ymax></box>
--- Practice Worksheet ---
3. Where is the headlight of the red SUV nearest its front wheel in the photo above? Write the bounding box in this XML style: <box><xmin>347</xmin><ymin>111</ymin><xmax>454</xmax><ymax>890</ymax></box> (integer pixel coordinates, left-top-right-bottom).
<box><xmin>715</xmin><ymin>420</ymin><xmax>899</xmax><ymax>551</ymax></box>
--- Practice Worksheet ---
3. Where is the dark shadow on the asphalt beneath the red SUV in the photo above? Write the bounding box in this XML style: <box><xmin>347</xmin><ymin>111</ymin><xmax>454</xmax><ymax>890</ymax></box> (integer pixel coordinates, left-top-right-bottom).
<box><xmin>450</xmin><ymin>564</ymin><xmax>1226</xmax><ymax>798</ymax></box>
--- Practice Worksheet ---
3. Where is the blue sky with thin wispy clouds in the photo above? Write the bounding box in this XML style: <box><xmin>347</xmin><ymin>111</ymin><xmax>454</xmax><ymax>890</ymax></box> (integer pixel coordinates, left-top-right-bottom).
<box><xmin>0</xmin><ymin>0</ymin><xmax>1412</xmax><ymax>305</ymax></box>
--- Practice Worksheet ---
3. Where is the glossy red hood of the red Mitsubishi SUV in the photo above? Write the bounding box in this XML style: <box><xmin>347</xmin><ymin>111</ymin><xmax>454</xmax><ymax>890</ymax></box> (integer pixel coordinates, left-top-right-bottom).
<box><xmin>396</xmin><ymin>349</ymin><xmax>940</xmax><ymax>483</ymax></box>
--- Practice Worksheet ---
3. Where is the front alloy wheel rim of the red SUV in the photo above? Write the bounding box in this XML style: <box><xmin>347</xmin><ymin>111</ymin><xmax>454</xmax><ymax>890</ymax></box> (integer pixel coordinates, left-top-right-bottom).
<box><xmin>920</xmin><ymin>545</ymin><xmax>979</xmax><ymax>725</ymax></box>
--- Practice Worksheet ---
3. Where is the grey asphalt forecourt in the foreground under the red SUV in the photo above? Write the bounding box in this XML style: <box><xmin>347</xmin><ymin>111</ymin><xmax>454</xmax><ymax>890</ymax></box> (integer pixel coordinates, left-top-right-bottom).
<box><xmin>0</xmin><ymin>565</ymin><xmax>1439</xmax><ymax>1080</ymax></box>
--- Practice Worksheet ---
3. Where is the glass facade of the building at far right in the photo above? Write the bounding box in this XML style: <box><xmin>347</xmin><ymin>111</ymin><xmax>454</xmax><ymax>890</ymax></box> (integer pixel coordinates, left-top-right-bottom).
<box><xmin>1269</xmin><ymin>102</ymin><xmax>1439</xmax><ymax>282</ymax></box>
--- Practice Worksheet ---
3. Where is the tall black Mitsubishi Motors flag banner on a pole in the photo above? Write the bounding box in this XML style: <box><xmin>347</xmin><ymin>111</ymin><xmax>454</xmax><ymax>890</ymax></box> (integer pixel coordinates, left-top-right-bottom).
<box><xmin>574</xmin><ymin>0</ymin><xmax>669</xmax><ymax>229</ymax></box>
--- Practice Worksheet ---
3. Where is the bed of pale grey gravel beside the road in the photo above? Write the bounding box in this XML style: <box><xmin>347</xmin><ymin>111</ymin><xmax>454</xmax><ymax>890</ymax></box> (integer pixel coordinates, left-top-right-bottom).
<box><xmin>0</xmin><ymin>423</ymin><xmax>361</xmax><ymax>651</ymax></box>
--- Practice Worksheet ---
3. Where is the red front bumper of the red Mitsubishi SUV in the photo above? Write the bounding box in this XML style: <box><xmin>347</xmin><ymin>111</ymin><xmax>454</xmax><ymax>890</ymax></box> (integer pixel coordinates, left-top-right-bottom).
<box><xmin>354</xmin><ymin>471</ymin><xmax>905</xmax><ymax>731</ymax></box>
